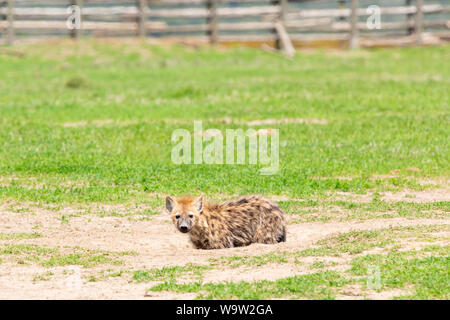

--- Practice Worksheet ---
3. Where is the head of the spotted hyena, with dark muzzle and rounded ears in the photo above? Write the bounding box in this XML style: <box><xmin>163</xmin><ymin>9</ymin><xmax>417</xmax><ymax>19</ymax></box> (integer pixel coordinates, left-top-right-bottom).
<box><xmin>166</xmin><ymin>196</ymin><xmax>203</xmax><ymax>233</ymax></box>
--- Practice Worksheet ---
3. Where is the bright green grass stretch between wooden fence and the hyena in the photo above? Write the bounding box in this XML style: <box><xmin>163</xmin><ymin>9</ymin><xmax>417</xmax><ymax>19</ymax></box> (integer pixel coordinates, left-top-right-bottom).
<box><xmin>0</xmin><ymin>43</ymin><xmax>450</xmax><ymax>202</ymax></box>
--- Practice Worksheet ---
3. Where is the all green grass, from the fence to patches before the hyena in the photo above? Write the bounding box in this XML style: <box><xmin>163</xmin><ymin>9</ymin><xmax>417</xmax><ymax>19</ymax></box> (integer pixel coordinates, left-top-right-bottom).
<box><xmin>0</xmin><ymin>40</ymin><xmax>450</xmax><ymax>299</ymax></box>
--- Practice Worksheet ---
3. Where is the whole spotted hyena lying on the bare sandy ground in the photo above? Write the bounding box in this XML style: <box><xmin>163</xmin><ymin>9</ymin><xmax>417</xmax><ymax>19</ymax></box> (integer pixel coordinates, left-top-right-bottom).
<box><xmin>166</xmin><ymin>195</ymin><xmax>286</xmax><ymax>249</ymax></box>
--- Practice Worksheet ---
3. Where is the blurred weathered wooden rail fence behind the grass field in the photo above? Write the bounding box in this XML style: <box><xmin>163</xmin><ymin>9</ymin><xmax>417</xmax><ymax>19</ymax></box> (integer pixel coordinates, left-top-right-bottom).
<box><xmin>0</xmin><ymin>0</ymin><xmax>450</xmax><ymax>50</ymax></box>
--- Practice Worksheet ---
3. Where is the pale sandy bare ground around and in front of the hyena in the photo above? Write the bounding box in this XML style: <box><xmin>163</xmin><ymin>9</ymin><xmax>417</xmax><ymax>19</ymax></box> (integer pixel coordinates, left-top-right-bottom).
<box><xmin>0</xmin><ymin>201</ymin><xmax>450</xmax><ymax>299</ymax></box>
